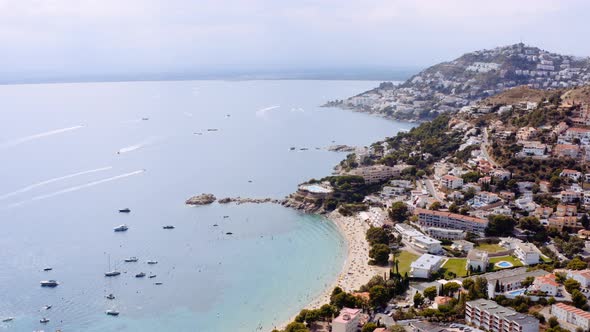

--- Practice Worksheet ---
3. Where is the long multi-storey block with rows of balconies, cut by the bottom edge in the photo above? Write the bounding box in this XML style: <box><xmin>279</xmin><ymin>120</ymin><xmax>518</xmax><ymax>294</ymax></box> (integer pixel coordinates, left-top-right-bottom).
<box><xmin>465</xmin><ymin>299</ymin><xmax>539</xmax><ymax>332</ymax></box>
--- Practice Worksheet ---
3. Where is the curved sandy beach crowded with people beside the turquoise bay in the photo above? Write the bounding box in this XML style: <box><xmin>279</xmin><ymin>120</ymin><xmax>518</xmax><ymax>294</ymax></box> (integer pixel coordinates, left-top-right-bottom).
<box><xmin>276</xmin><ymin>211</ymin><xmax>389</xmax><ymax>330</ymax></box>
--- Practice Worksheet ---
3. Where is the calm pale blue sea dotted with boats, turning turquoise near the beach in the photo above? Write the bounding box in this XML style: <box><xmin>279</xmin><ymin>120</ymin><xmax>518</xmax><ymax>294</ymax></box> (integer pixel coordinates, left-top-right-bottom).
<box><xmin>0</xmin><ymin>80</ymin><xmax>413</xmax><ymax>332</ymax></box>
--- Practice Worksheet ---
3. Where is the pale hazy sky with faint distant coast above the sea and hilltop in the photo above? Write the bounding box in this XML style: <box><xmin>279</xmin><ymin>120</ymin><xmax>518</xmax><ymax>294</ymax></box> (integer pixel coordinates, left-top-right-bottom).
<box><xmin>0</xmin><ymin>0</ymin><xmax>590</xmax><ymax>78</ymax></box>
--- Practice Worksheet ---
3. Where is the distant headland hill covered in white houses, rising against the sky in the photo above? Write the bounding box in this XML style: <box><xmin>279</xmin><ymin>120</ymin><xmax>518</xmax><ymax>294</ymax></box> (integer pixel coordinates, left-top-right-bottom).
<box><xmin>326</xmin><ymin>43</ymin><xmax>590</xmax><ymax>120</ymax></box>
